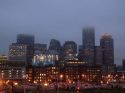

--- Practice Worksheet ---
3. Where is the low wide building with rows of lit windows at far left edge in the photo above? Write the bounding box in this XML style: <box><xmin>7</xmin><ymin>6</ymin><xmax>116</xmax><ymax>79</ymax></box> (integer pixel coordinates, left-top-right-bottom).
<box><xmin>0</xmin><ymin>55</ymin><xmax>25</xmax><ymax>81</ymax></box>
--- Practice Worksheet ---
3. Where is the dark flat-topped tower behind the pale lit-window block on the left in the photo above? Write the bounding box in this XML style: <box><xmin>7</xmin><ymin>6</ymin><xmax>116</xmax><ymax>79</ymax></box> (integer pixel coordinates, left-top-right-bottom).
<box><xmin>17</xmin><ymin>34</ymin><xmax>35</xmax><ymax>80</ymax></box>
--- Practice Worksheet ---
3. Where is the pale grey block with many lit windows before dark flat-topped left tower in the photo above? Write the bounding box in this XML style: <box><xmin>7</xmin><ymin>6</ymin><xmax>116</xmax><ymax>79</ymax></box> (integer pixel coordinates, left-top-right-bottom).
<box><xmin>8</xmin><ymin>43</ymin><xmax>31</xmax><ymax>67</ymax></box>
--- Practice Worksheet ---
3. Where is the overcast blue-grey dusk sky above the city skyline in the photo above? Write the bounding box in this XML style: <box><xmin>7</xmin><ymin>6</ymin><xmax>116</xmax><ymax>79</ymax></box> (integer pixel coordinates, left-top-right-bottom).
<box><xmin>0</xmin><ymin>0</ymin><xmax>125</xmax><ymax>65</ymax></box>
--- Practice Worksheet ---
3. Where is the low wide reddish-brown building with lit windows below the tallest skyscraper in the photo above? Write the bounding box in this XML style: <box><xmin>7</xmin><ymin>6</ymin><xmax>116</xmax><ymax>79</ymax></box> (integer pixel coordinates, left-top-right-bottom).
<box><xmin>63</xmin><ymin>60</ymin><xmax>102</xmax><ymax>83</ymax></box>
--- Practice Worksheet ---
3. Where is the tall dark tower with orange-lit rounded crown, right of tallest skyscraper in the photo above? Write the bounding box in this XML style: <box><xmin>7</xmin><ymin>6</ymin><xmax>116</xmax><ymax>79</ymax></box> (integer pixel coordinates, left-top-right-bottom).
<box><xmin>100</xmin><ymin>33</ymin><xmax>114</xmax><ymax>65</ymax></box>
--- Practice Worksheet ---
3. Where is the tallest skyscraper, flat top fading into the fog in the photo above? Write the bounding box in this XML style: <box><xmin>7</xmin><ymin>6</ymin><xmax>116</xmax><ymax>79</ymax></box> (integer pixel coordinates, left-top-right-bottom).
<box><xmin>82</xmin><ymin>27</ymin><xmax>95</xmax><ymax>64</ymax></box>
